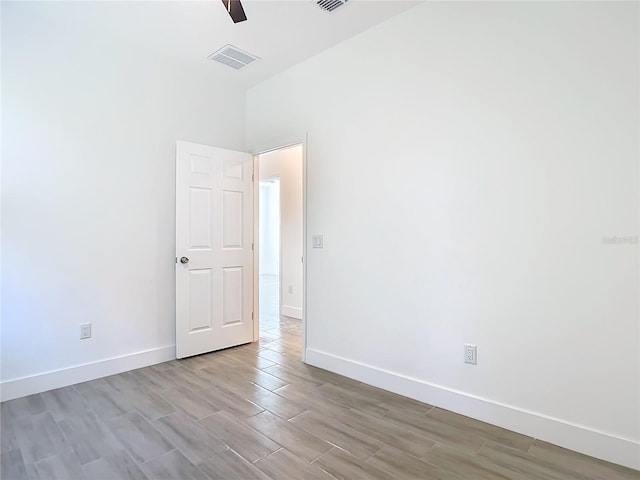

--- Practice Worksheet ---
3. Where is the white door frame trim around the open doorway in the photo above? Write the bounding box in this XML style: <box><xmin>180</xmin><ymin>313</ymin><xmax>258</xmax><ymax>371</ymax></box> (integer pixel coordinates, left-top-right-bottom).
<box><xmin>251</xmin><ymin>133</ymin><xmax>308</xmax><ymax>362</ymax></box>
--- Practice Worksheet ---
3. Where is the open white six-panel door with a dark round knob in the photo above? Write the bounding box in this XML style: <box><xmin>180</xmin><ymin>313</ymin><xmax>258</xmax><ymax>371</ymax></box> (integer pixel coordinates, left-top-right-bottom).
<box><xmin>176</xmin><ymin>142</ymin><xmax>253</xmax><ymax>358</ymax></box>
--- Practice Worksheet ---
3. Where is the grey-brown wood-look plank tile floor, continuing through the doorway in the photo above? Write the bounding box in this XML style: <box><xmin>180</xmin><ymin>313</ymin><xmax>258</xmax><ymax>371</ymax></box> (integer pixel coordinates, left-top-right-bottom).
<box><xmin>0</xmin><ymin>312</ymin><xmax>640</xmax><ymax>480</ymax></box>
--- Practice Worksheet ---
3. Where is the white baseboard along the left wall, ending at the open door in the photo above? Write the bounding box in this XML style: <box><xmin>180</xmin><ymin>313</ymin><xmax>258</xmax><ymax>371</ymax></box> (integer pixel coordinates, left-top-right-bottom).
<box><xmin>0</xmin><ymin>345</ymin><xmax>176</xmax><ymax>401</ymax></box>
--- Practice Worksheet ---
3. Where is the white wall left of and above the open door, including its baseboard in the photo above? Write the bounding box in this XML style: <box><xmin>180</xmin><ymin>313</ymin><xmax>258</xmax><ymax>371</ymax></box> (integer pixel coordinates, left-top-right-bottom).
<box><xmin>1</xmin><ymin>2</ymin><xmax>244</xmax><ymax>399</ymax></box>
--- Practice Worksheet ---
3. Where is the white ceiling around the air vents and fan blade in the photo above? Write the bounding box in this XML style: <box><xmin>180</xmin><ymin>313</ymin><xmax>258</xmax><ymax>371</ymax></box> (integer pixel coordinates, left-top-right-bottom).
<box><xmin>22</xmin><ymin>0</ymin><xmax>421</xmax><ymax>87</ymax></box>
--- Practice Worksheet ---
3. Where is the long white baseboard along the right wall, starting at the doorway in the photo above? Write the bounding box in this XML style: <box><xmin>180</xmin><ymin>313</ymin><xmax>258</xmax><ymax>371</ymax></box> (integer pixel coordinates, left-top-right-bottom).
<box><xmin>306</xmin><ymin>348</ymin><xmax>640</xmax><ymax>470</ymax></box>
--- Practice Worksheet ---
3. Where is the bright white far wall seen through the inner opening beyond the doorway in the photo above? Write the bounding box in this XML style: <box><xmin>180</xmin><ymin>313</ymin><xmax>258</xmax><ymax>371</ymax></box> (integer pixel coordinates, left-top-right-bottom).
<box><xmin>259</xmin><ymin>181</ymin><xmax>280</xmax><ymax>275</ymax></box>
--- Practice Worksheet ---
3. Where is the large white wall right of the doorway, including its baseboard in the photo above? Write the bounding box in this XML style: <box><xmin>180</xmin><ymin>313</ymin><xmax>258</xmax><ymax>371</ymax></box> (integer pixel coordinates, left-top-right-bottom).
<box><xmin>247</xmin><ymin>2</ymin><xmax>640</xmax><ymax>468</ymax></box>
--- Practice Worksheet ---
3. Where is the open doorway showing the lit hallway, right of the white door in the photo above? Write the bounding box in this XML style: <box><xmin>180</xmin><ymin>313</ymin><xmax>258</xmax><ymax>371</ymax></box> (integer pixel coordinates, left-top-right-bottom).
<box><xmin>255</xmin><ymin>144</ymin><xmax>304</xmax><ymax>361</ymax></box>
